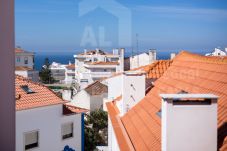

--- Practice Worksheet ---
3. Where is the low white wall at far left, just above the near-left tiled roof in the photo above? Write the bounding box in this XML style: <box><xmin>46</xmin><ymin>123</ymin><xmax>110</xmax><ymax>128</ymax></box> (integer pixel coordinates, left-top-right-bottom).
<box><xmin>15</xmin><ymin>70</ymin><xmax>39</xmax><ymax>82</ymax></box>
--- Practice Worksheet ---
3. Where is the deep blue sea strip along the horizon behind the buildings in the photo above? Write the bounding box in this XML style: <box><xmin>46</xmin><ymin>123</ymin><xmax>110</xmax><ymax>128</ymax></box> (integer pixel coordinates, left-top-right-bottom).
<box><xmin>35</xmin><ymin>51</ymin><xmax>206</xmax><ymax>71</ymax></box>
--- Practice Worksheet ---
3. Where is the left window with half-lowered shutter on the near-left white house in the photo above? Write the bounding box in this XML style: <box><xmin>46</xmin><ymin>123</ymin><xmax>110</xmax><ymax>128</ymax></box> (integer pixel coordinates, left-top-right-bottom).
<box><xmin>24</xmin><ymin>131</ymin><xmax>39</xmax><ymax>150</ymax></box>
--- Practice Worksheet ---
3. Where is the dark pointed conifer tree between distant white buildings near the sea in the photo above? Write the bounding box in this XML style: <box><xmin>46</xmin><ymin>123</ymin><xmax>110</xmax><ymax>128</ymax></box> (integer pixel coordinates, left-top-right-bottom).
<box><xmin>39</xmin><ymin>58</ymin><xmax>55</xmax><ymax>84</ymax></box>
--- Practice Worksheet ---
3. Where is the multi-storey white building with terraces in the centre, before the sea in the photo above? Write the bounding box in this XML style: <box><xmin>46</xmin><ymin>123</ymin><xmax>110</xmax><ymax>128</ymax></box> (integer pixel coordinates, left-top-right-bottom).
<box><xmin>74</xmin><ymin>49</ymin><xmax>124</xmax><ymax>89</ymax></box>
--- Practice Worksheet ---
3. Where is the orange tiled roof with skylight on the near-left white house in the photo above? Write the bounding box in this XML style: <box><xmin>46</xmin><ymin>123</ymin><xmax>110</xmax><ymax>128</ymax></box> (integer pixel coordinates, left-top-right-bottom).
<box><xmin>15</xmin><ymin>75</ymin><xmax>85</xmax><ymax>113</ymax></box>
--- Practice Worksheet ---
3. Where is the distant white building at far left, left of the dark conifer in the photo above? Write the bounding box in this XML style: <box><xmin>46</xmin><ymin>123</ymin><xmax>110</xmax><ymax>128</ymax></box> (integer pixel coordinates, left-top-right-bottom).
<box><xmin>15</xmin><ymin>47</ymin><xmax>39</xmax><ymax>82</ymax></box>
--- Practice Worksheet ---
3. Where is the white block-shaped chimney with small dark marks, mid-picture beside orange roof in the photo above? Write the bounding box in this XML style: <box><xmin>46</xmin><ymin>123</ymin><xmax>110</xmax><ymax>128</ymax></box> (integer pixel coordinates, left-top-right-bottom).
<box><xmin>122</xmin><ymin>71</ymin><xmax>145</xmax><ymax>114</ymax></box>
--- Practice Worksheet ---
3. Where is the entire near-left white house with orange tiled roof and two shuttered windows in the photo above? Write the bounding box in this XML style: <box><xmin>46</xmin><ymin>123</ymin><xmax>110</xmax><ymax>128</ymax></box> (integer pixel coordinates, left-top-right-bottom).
<box><xmin>15</xmin><ymin>76</ymin><xmax>86</xmax><ymax>151</ymax></box>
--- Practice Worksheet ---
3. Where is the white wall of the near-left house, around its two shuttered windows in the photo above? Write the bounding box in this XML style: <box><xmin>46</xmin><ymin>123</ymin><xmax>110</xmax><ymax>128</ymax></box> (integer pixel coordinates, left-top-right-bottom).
<box><xmin>16</xmin><ymin>105</ymin><xmax>82</xmax><ymax>151</ymax></box>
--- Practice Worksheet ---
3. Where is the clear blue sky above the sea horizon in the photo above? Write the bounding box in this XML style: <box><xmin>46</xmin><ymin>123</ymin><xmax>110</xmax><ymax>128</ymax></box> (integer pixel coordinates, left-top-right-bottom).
<box><xmin>15</xmin><ymin>0</ymin><xmax>227</xmax><ymax>52</ymax></box>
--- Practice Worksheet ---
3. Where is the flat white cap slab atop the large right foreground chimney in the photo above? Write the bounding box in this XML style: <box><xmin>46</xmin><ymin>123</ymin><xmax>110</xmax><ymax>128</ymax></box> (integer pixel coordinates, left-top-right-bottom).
<box><xmin>160</xmin><ymin>94</ymin><xmax>218</xmax><ymax>100</ymax></box>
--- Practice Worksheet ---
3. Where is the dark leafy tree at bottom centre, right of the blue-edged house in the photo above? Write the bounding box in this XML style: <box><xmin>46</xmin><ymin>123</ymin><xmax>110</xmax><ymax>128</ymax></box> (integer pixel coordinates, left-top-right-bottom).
<box><xmin>85</xmin><ymin>109</ymin><xmax>108</xmax><ymax>151</ymax></box>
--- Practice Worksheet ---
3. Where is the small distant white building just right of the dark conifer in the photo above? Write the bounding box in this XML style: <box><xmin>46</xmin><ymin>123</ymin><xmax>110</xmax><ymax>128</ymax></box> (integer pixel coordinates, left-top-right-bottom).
<box><xmin>49</xmin><ymin>62</ymin><xmax>67</xmax><ymax>82</ymax></box>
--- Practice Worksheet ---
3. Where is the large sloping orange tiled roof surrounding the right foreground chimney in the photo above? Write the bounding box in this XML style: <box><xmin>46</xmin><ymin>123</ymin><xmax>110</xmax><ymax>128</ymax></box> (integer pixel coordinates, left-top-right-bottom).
<box><xmin>108</xmin><ymin>51</ymin><xmax>227</xmax><ymax>151</ymax></box>
